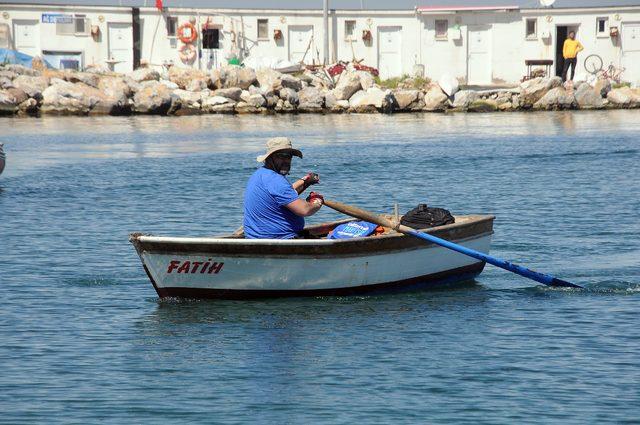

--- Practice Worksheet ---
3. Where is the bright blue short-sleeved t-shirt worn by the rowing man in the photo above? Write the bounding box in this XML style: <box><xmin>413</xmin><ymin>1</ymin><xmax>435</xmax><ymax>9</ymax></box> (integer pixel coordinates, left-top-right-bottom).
<box><xmin>244</xmin><ymin>167</ymin><xmax>304</xmax><ymax>239</ymax></box>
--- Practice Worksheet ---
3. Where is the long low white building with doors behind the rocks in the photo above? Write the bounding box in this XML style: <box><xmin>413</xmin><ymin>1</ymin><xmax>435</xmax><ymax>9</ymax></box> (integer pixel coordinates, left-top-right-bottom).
<box><xmin>0</xmin><ymin>0</ymin><xmax>640</xmax><ymax>84</ymax></box>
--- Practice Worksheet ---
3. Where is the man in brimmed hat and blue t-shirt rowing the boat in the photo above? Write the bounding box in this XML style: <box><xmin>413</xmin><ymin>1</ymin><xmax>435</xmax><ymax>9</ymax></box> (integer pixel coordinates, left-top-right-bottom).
<box><xmin>244</xmin><ymin>137</ymin><xmax>324</xmax><ymax>239</ymax></box>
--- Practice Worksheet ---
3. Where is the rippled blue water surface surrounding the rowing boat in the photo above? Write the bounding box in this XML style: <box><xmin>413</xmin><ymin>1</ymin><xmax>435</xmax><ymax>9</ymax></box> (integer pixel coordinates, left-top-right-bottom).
<box><xmin>0</xmin><ymin>111</ymin><xmax>640</xmax><ymax>424</ymax></box>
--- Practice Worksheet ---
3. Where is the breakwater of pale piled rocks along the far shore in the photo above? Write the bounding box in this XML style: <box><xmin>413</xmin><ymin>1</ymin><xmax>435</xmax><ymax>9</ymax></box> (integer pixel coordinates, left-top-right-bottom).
<box><xmin>0</xmin><ymin>65</ymin><xmax>640</xmax><ymax>116</ymax></box>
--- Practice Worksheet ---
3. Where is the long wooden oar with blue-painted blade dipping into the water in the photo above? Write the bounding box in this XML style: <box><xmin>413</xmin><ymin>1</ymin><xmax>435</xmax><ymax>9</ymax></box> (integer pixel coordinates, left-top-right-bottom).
<box><xmin>324</xmin><ymin>199</ymin><xmax>582</xmax><ymax>288</ymax></box>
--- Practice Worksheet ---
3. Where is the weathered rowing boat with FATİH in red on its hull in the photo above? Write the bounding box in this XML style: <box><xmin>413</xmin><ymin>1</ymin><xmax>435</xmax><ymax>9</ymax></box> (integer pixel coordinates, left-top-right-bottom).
<box><xmin>130</xmin><ymin>215</ymin><xmax>494</xmax><ymax>299</ymax></box>
